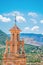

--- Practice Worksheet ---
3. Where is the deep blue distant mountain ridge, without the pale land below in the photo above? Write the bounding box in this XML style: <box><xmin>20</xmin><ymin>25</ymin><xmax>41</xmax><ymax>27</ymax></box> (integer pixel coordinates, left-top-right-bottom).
<box><xmin>20</xmin><ymin>33</ymin><xmax>43</xmax><ymax>42</ymax></box>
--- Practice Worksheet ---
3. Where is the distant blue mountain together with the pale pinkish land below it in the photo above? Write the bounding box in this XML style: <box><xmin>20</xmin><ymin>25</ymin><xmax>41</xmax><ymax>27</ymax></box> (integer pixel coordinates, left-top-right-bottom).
<box><xmin>20</xmin><ymin>33</ymin><xmax>43</xmax><ymax>46</ymax></box>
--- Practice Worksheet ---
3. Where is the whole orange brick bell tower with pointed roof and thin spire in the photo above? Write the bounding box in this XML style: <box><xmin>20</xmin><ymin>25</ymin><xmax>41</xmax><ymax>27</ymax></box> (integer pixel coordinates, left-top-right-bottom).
<box><xmin>3</xmin><ymin>16</ymin><xmax>26</xmax><ymax>65</ymax></box>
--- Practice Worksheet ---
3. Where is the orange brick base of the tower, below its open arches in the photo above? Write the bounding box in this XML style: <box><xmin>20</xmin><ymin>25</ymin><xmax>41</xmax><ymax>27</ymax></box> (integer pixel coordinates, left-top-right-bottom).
<box><xmin>3</xmin><ymin>55</ymin><xmax>26</xmax><ymax>65</ymax></box>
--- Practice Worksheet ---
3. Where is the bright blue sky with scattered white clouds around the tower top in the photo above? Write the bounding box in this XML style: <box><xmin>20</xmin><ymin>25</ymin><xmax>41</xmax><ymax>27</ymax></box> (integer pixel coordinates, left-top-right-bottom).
<box><xmin>0</xmin><ymin>0</ymin><xmax>43</xmax><ymax>34</ymax></box>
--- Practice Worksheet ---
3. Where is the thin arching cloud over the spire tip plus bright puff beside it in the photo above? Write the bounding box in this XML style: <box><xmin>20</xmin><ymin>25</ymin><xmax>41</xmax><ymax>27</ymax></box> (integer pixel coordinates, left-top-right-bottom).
<box><xmin>3</xmin><ymin>11</ymin><xmax>26</xmax><ymax>22</ymax></box>
